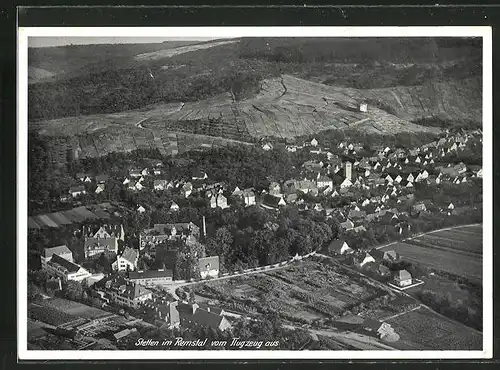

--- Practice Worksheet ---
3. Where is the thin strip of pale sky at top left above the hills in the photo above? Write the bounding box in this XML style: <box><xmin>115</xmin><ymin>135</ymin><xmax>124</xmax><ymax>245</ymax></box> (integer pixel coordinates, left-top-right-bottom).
<box><xmin>28</xmin><ymin>36</ymin><xmax>218</xmax><ymax>48</ymax></box>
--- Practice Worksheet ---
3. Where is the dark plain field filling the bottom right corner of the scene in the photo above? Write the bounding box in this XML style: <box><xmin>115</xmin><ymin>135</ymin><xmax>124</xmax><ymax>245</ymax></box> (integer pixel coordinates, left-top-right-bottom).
<box><xmin>387</xmin><ymin>307</ymin><xmax>482</xmax><ymax>350</ymax></box>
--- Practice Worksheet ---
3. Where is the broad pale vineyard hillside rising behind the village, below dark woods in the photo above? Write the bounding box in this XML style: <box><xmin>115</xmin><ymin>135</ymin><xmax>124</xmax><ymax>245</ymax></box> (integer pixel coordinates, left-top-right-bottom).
<box><xmin>30</xmin><ymin>75</ymin><xmax>480</xmax><ymax>163</ymax></box>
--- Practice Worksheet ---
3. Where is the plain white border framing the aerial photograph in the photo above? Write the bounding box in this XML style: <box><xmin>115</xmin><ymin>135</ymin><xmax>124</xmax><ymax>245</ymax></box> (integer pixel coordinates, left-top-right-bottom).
<box><xmin>17</xmin><ymin>26</ymin><xmax>493</xmax><ymax>360</ymax></box>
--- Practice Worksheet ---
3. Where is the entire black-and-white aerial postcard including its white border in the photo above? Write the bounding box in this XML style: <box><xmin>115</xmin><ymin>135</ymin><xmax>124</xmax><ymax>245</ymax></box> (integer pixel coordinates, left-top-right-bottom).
<box><xmin>17</xmin><ymin>27</ymin><xmax>493</xmax><ymax>359</ymax></box>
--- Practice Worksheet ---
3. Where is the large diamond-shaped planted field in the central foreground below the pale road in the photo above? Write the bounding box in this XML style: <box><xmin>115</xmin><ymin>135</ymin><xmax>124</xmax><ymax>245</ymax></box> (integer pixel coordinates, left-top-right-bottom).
<box><xmin>192</xmin><ymin>261</ymin><xmax>404</xmax><ymax>323</ymax></box>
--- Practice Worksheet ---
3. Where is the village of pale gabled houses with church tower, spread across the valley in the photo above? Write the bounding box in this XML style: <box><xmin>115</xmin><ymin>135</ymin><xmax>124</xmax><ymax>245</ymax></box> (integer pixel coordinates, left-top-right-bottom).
<box><xmin>28</xmin><ymin>125</ymin><xmax>482</xmax><ymax>348</ymax></box>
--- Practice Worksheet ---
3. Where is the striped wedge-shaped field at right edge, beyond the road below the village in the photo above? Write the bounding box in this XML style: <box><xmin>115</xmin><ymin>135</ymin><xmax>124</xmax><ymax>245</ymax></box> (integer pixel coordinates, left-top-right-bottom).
<box><xmin>383</xmin><ymin>227</ymin><xmax>483</xmax><ymax>282</ymax></box>
